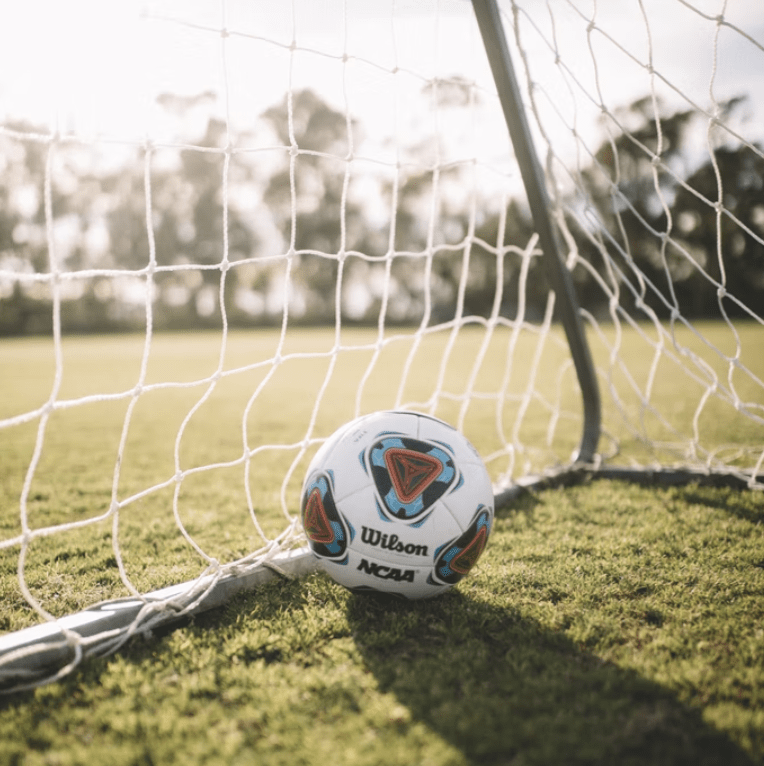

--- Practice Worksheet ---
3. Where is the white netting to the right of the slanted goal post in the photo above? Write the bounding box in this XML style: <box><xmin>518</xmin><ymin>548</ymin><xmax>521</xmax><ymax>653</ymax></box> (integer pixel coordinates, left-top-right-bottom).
<box><xmin>512</xmin><ymin>0</ymin><xmax>764</xmax><ymax>486</ymax></box>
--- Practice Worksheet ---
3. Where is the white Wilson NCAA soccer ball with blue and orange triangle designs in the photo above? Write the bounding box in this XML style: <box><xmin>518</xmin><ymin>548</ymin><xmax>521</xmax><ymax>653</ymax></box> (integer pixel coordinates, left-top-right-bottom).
<box><xmin>301</xmin><ymin>411</ymin><xmax>493</xmax><ymax>599</ymax></box>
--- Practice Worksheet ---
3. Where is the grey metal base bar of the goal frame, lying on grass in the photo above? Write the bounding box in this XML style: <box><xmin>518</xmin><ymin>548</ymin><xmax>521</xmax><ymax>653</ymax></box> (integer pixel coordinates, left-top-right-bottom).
<box><xmin>0</xmin><ymin>464</ymin><xmax>764</xmax><ymax>694</ymax></box>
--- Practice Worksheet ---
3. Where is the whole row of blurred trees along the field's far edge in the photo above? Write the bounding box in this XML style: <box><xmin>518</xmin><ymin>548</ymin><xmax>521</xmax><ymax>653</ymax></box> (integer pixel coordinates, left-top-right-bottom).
<box><xmin>0</xmin><ymin>90</ymin><xmax>764</xmax><ymax>335</ymax></box>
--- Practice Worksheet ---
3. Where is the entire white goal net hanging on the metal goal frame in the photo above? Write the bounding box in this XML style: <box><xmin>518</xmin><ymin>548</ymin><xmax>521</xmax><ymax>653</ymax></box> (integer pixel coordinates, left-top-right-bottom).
<box><xmin>0</xmin><ymin>0</ymin><xmax>764</xmax><ymax>689</ymax></box>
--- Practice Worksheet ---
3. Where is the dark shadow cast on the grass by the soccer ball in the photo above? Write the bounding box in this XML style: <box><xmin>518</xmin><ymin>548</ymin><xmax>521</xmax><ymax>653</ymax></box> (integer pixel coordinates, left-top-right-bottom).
<box><xmin>348</xmin><ymin>592</ymin><xmax>753</xmax><ymax>766</ymax></box>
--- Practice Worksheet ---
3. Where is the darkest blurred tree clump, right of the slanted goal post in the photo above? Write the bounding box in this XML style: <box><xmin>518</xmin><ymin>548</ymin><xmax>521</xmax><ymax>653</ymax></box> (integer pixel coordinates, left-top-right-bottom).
<box><xmin>569</xmin><ymin>98</ymin><xmax>764</xmax><ymax>317</ymax></box>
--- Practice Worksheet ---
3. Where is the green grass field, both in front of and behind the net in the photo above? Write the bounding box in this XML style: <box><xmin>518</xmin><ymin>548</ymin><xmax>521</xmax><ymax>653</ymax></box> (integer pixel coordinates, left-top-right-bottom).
<box><xmin>0</xmin><ymin>327</ymin><xmax>764</xmax><ymax>766</ymax></box>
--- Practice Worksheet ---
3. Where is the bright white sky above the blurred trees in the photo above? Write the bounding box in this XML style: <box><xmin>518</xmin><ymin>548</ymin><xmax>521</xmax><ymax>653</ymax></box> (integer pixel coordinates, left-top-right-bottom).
<box><xmin>0</xmin><ymin>0</ymin><xmax>764</xmax><ymax>153</ymax></box>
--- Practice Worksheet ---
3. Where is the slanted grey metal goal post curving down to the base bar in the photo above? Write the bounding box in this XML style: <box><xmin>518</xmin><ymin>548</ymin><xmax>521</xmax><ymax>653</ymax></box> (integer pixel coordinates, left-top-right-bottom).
<box><xmin>472</xmin><ymin>0</ymin><xmax>601</xmax><ymax>463</ymax></box>
